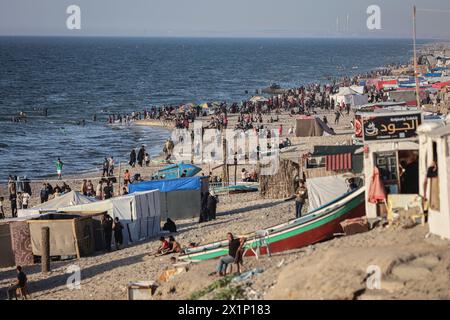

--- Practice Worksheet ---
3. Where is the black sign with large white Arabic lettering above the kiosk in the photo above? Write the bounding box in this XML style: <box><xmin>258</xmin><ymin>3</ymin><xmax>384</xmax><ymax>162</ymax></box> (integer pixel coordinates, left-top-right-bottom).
<box><xmin>362</xmin><ymin>112</ymin><xmax>422</xmax><ymax>141</ymax></box>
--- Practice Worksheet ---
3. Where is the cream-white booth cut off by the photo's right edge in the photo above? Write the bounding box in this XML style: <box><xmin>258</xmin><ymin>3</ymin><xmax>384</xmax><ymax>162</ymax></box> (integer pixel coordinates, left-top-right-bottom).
<box><xmin>418</xmin><ymin>123</ymin><xmax>450</xmax><ymax>239</ymax></box>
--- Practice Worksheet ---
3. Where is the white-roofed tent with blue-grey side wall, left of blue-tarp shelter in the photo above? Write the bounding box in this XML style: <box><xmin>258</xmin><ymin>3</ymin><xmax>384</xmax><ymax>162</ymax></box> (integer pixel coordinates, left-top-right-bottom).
<box><xmin>63</xmin><ymin>190</ymin><xmax>161</xmax><ymax>245</ymax></box>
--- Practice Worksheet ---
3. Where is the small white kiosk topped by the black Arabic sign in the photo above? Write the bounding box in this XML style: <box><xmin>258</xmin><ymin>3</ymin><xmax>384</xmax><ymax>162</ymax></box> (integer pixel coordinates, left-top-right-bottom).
<box><xmin>357</xmin><ymin>111</ymin><xmax>423</xmax><ymax>218</ymax></box>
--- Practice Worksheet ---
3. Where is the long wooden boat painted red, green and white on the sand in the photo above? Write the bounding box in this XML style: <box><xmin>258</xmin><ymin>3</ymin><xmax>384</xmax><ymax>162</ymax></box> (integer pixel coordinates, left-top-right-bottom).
<box><xmin>179</xmin><ymin>187</ymin><xmax>365</xmax><ymax>261</ymax></box>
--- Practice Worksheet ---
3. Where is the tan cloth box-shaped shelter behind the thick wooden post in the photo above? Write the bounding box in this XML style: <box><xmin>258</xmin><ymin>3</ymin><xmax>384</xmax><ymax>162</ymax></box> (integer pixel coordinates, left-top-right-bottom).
<box><xmin>27</xmin><ymin>212</ymin><xmax>104</xmax><ymax>258</ymax></box>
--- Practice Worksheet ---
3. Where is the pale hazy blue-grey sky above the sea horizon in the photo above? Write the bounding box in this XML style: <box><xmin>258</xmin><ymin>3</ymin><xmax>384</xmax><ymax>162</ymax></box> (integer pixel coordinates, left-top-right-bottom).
<box><xmin>0</xmin><ymin>0</ymin><xmax>450</xmax><ymax>40</ymax></box>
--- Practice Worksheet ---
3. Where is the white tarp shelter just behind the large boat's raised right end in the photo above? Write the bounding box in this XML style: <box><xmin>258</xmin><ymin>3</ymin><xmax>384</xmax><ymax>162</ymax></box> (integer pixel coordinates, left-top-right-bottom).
<box><xmin>306</xmin><ymin>175</ymin><xmax>347</xmax><ymax>211</ymax></box>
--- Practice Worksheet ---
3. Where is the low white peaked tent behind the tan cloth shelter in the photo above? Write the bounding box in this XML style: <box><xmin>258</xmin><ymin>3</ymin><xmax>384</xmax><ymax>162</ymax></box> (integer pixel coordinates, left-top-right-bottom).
<box><xmin>17</xmin><ymin>191</ymin><xmax>97</xmax><ymax>217</ymax></box>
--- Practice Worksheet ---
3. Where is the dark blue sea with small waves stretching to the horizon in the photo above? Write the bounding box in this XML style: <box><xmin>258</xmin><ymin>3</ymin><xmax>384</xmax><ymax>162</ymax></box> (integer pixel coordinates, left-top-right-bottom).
<box><xmin>0</xmin><ymin>37</ymin><xmax>422</xmax><ymax>180</ymax></box>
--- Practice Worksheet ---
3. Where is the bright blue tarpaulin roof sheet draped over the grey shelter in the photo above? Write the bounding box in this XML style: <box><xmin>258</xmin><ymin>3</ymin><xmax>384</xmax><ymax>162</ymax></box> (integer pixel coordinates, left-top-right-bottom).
<box><xmin>128</xmin><ymin>177</ymin><xmax>201</xmax><ymax>193</ymax></box>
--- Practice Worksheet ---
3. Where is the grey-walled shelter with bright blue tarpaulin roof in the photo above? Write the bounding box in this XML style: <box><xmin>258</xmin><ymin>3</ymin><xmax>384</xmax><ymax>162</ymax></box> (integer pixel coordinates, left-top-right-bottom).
<box><xmin>128</xmin><ymin>177</ymin><xmax>209</xmax><ymax>220</ymax></box>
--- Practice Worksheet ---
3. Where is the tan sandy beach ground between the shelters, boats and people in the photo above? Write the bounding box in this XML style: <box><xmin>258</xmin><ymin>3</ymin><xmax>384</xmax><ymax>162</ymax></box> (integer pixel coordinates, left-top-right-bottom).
<box><xmin>0</xmin><ymin>41</ymin><xmax>450</xmax><ymax>300</ymax></box>
